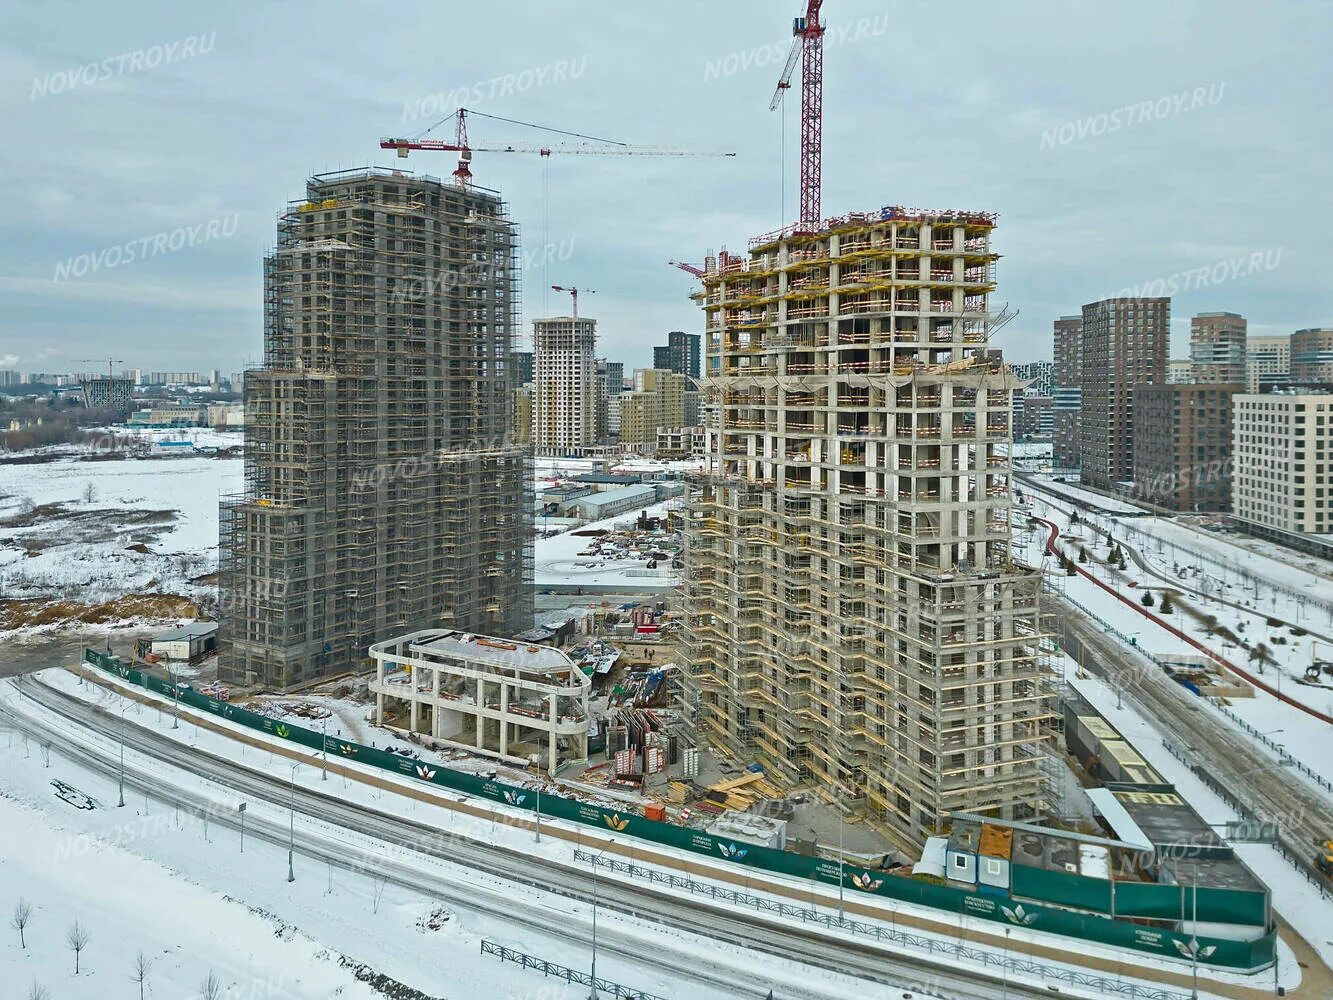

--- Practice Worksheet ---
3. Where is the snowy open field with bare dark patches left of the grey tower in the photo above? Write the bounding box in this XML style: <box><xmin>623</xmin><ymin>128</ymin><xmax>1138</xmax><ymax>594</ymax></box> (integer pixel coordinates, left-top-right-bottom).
<box><xmin>0</xmin><ymin>453</ymin><xmax>243</xmax><ymax>601</ymax></box>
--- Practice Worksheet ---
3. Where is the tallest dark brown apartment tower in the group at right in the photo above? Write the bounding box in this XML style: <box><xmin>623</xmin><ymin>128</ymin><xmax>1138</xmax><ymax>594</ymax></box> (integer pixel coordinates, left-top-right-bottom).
<box><xmin>1078</xmin><ymin>297</ymin><xmax>1170</xmax><ymax>489</ymax></box>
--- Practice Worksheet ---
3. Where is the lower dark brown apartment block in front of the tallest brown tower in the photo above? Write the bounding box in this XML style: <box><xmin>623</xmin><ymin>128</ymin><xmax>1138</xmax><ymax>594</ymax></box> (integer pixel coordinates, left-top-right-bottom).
<box><xmin>1134</xmin><ymin>383</ymin><xmax>1245</xmax><ymax>512</ymax></box>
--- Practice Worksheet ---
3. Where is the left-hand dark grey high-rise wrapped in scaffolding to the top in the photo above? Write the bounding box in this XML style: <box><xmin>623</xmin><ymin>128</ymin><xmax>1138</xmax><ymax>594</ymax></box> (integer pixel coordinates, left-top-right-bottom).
<box><xmin>220</xmin><ymin>168</ymin><xmax>532</xmax><ymax>688</ymax></box>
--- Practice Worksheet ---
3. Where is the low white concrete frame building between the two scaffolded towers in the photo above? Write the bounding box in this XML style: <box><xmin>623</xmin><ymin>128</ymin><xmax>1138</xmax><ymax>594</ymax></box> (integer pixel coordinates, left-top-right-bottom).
<box><xmin>371</xmin><ymin>629</ymin><xmax>592</xmax><ymax>776</ymax></box>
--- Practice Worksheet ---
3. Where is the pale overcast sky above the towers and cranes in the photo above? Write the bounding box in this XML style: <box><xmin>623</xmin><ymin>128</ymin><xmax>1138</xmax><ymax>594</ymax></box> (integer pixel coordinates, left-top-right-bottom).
<box><xmin>0</xmin><ymin>0</ymin><xmax>1333</xmax><ymax>372</ymax></box>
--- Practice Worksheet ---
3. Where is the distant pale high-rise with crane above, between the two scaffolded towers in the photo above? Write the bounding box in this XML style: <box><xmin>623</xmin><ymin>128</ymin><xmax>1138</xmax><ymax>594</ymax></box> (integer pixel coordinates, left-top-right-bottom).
<box><xmin>532</xmin><ymin>316</ymin><xmax>599</xmax><ymax>456</ymax></box>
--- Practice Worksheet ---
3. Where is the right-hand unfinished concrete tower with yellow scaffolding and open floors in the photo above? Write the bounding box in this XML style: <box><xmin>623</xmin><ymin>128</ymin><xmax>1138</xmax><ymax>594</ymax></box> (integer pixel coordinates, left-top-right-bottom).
<box><xmin>684</xmin><ymin>208</ymin><xmax>1053</xmax><ymax>848</ymax></box>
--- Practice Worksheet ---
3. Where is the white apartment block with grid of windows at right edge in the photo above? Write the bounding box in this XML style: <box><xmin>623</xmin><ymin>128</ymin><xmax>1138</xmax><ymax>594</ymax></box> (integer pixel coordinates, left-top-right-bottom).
<box><xmin>1232</xmin><ymin>385</ymin><xmax>1333</xmax><ymax>557</ymax></box>
